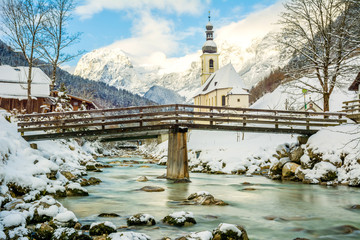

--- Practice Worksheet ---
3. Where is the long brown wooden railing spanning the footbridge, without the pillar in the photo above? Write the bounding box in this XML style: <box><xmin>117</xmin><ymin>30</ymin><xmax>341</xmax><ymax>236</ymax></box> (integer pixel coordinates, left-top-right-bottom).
<box><xmin>18</xmin><ymin>104</ymin><xmax>346</xmax><ymax>140</ymax></box>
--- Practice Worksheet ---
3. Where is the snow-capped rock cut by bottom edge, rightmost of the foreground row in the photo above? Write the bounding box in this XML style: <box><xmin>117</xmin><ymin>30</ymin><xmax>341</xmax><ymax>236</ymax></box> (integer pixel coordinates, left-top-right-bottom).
<box><xmin>213</xmin><ymin>223</ymin><xmax>249</xmax><ymax>240</ymax></box>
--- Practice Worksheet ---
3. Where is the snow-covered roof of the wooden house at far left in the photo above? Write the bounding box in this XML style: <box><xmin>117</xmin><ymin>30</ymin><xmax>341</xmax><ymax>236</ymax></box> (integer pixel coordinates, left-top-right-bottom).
<box><xmin>0</xmin><ymin>65</ymin><xmax>51</xmax><ymax>100</ymax></box>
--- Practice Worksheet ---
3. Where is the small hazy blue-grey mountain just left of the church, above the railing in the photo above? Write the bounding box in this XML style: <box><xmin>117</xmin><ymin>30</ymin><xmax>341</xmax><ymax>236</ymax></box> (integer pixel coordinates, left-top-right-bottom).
<box><xmin>144</xmin><ymin>85</ymin><xmax>185</xmax><ymax>104</ymax></box>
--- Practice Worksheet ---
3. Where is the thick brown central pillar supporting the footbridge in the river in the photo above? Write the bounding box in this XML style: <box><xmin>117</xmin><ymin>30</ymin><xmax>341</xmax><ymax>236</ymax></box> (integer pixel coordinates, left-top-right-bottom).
<box><xmin>166</xmin><ymin>126</ymin><xmax>189</xmax><ymax>181</ymax></box>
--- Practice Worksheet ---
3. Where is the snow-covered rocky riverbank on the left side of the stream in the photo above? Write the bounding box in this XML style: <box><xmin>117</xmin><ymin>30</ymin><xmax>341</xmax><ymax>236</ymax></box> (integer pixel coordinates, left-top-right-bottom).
<box><xmin>0</xmin><ymin>112</ymin><xmax>129</xmax><ymax>239</ymax></box>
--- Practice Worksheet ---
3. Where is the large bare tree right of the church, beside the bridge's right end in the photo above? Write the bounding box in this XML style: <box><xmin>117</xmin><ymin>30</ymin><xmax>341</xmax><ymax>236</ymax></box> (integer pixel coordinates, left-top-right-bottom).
<box><xmin>278</xmin><ymin>0</ymin><xmax>360</xmax><ymax>111</ymax></box>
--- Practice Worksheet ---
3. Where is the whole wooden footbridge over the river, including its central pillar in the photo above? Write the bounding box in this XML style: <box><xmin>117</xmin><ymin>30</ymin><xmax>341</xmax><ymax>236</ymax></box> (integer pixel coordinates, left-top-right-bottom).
<box><xmin>18</xmin><ymin>104</ymin><xmax>346</xmax><ymax>179</ymax></box>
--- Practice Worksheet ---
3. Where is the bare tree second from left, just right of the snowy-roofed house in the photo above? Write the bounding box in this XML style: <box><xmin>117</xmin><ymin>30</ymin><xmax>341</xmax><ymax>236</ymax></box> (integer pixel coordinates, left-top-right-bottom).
<box><xmin>39</xmin><ymin>0</ymin><xmax>83</xmax><ymax>90</ymax></box>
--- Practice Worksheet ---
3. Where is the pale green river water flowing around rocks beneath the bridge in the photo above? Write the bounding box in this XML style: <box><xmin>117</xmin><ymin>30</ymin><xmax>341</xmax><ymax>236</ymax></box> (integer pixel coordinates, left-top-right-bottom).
<box><xmin>61</xmin><ymin>157</ymin><xmax>360</xmax><ymax>240</ymax></box>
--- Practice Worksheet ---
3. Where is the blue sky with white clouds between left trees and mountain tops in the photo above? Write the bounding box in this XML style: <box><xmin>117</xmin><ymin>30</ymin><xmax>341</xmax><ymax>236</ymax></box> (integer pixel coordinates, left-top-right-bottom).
<box><xmin>67</xmin><ymin>0</ymin><xmax>279</xmax><ymax>66</ymax></box>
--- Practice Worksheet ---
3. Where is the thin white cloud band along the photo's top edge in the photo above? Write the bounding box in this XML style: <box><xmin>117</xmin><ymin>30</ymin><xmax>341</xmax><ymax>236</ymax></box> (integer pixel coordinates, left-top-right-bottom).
<box><xmin>75</xmin><ymin>0</ymin><xmax>210</xmax><ymax>19</ymax></box>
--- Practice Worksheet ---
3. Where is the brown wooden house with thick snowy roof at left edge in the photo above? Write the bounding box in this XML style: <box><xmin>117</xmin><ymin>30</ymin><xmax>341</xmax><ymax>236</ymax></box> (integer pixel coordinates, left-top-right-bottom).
<box><xmin>0</xmin><ymin>65</ymin><xmax>51</xmax><ymax>112</ymax></box>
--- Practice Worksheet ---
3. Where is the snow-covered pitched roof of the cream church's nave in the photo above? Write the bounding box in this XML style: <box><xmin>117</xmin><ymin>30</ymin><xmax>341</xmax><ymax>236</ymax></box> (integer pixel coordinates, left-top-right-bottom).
<box><xmin>196</xmin><ymin>63</ymin><xmax>249</xmax><ymax>96</ymax></box>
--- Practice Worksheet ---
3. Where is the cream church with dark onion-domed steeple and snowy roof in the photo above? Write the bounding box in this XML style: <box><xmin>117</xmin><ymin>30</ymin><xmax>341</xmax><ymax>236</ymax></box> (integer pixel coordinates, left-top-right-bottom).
<box><xmin>194</xmin><ymin>16</ymin><xmax>249</xmax><ymax>108</ymax></box>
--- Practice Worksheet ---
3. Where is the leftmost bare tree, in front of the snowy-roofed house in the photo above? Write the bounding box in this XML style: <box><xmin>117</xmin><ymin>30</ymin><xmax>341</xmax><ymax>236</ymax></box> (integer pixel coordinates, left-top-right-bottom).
<box><xmin>1</xmin><ymin>0</ymin><xmax>47</xmax><ymax>112</ymax></box>
